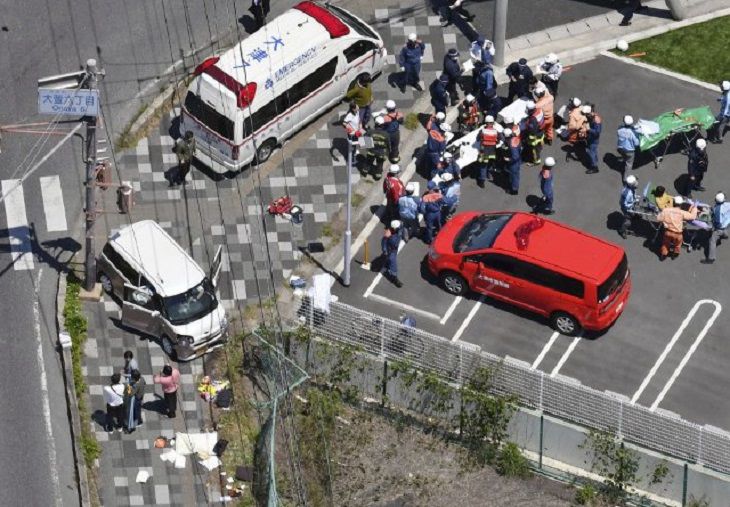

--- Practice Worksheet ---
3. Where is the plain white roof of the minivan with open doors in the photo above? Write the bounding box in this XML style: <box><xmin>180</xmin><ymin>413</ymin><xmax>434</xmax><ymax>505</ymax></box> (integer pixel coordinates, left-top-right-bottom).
<box><xmin>109</xmin><ymin>220</ymin><xmax>206</xmax><ymax>297</ymax></box>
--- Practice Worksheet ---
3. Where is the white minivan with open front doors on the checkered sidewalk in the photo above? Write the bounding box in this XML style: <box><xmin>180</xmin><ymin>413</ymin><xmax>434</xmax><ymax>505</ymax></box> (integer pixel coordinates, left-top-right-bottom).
<box><xmin>97</xmin><ymin>220</ymin><xmax>228</xmax><ymax>361</ymax></box>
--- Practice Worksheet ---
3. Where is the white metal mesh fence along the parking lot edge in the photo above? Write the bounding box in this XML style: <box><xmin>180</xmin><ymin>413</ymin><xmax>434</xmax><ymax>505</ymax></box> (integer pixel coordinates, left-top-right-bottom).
<box><xmin>300</xmin><ymin>298</ymin><xmax>730</xmax><ymax>474</ymax></box>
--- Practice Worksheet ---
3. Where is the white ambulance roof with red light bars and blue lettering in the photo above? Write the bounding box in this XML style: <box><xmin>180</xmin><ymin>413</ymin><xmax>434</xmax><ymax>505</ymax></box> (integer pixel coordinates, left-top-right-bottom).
<box><xmin>191</xmin><ymin>1</ymin><xmax>362</xmax><ymax>111</ymax></box>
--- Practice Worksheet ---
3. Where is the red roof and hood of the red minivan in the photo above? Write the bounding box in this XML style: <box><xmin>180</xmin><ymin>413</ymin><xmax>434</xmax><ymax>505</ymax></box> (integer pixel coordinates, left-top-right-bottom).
<box><xmin>434</xmin><ymin>211</ymin><xmax>624</xmax><ymax>283</ymax></box>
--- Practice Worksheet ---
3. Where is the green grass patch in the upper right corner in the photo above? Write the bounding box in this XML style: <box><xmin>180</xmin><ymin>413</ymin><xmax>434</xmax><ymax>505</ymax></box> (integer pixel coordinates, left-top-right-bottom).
<box><xmin>616</xmin><ymin>16</ymin><xmax>730</xmax><ymax>84</ymax></box>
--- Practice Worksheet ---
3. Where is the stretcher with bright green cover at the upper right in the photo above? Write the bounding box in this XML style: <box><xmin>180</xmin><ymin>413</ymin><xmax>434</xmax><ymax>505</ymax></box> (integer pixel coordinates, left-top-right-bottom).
<box><xmin>637</xmin><ymin>106</ymin><xmax>715</xmax><ymax>168</ymax></box>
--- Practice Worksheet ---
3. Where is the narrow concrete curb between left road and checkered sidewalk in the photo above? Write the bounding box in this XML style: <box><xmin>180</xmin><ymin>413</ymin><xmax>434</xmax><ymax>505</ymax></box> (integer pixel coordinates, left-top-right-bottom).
<box><xmin>56</xmin><ymin>272</ymin><xmax>91</xmax><ymax>507</ymax></box>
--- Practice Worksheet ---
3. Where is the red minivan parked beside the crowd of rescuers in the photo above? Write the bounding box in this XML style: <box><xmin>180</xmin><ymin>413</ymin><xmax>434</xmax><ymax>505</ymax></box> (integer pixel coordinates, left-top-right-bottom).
<box><xmin>427</xmin><ymin>211</ymin><xmax>631</xmax><ymax>336</ymax></box>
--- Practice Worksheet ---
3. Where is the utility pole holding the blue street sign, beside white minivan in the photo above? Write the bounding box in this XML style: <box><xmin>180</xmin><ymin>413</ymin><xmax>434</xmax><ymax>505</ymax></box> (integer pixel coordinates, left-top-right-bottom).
<box><xmin>84</xmin><ymin>58</ymin><xmax>98</xmax><ymax>292</ymax></box>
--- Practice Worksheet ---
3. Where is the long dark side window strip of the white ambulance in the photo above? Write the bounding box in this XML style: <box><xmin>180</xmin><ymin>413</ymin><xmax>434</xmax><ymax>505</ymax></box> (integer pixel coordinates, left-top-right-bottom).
<box><xmin>243</xmin><ymin>57</ymin><xmax>337</xmax><ymax>139</ymax></box>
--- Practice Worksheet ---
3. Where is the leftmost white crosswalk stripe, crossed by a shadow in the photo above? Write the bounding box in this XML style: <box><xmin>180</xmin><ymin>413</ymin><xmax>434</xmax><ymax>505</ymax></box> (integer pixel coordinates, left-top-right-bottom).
<box><xmin>0</xmin><ymin>180</ymin><xmax>34</xmax><ymax>271</ymax></box>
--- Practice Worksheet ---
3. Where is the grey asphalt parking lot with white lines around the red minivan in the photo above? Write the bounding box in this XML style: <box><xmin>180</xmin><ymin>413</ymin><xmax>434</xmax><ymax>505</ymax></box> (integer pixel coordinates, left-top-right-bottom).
<box><xmin>333</xmin><ymin>57</ymin><xmax>730</xmax><ymax>427</ymax></box>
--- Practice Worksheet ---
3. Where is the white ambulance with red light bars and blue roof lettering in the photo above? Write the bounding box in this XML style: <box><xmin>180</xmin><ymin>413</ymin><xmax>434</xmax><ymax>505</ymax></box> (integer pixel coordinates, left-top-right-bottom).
<box><xmin>180</xmin><ymin>1</ymin><xmax>387</xmax><ymax>173</ymax></box>
